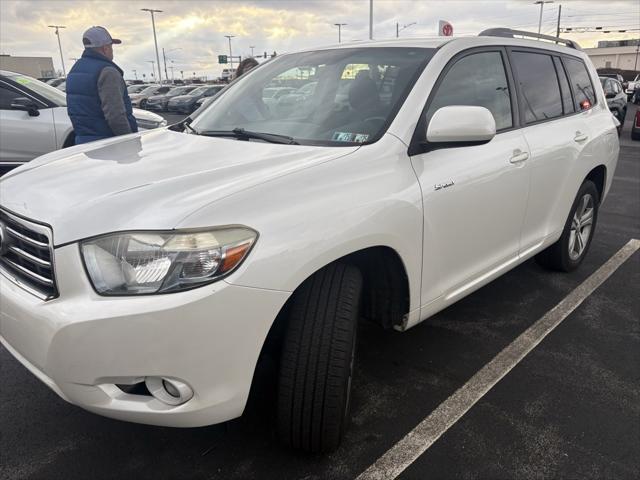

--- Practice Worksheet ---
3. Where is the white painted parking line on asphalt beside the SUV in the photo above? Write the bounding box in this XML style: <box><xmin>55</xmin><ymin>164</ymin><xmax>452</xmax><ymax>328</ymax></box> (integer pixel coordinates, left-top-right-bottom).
<box><xmin>357</xmin><ymin>239</ymin><xmax>640</xmax><ymax>480</ymax></box>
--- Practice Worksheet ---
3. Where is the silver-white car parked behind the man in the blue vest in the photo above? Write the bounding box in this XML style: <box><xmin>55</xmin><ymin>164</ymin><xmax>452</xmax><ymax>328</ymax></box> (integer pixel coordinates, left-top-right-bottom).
<box><xmin>0</xmin><ymin>70</ymin><xmax>167</xmax><ymax>174</ymax></box>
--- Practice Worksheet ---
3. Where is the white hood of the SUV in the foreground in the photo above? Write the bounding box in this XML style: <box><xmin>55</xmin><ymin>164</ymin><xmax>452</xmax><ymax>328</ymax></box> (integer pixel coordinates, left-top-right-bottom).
<box><xmin>0</xmin><ymin>129</ymin><xmax>359</xmax><ymax>245</ymax></box>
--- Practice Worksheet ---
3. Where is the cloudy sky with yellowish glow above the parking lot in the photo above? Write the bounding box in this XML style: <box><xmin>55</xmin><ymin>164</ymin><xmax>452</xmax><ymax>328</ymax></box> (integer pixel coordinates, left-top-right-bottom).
<box><xmin>0</xmin><ymin>0</ymin><xmax>640</xmax><ymax>79</ymax></box>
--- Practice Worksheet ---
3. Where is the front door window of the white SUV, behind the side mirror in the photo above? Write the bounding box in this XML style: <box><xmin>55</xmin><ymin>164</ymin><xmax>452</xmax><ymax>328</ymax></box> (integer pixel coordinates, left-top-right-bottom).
<box><xmin>427</xmin><ymin>52</ymin><xmax>513</xmax><ymax>130</ymax></box>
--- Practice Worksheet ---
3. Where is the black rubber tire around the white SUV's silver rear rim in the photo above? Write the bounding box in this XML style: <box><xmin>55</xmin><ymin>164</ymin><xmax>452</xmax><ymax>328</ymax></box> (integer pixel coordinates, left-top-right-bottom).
<box><xmin>536</xmin><ymin>180</ymin><xmax>600</xmax><ymax>272</ymax></box>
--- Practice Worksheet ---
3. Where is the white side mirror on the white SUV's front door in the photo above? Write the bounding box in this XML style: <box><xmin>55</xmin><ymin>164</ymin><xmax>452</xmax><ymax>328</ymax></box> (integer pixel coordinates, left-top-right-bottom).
<box><xmin>427</xmin><ymin>105</ymin><xmax>496</xmax><ymax>146</ymax></box>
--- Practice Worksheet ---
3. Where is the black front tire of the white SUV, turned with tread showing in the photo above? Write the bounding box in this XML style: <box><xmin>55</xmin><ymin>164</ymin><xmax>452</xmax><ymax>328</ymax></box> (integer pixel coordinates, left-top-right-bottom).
<box><xmin>277</xmin><ymin>263</ymin><xmax>362</xmax><ymax>452</ymax></box>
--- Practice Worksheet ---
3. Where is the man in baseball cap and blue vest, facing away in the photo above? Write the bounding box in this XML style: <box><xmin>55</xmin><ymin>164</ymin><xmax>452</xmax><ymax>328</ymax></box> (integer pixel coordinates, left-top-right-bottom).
<box><xmin>67</xmin><ymin>27</ymin><xmax>138</xmax><ymax>145</ymax></box>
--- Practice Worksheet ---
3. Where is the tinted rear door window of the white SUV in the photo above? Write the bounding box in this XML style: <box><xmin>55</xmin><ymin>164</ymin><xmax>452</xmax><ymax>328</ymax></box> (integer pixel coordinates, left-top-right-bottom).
<box><xmin>512</xmin><ymin>52</ymin><xmax>563</xmax><ymax>123</ymax></box>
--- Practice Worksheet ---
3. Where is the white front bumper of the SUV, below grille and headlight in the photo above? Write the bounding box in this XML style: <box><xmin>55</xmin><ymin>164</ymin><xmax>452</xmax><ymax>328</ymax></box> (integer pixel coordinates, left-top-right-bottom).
<box><xmin>0</xmin><ymin>245</ymin><xmax>290</xmax><ymax>427</ymax></box>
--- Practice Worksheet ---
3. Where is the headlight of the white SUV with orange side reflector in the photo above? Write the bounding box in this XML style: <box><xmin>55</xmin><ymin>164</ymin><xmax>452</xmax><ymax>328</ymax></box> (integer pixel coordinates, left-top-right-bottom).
<box><xmin>80</xmin><ymin>227</ymin><xmax>258</xmax><ymax>295</ymax></box>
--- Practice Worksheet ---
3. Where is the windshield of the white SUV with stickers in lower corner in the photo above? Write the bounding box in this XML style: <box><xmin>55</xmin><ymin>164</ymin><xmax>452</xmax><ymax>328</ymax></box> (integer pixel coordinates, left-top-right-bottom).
<box><xmin>190</xmin><ymin>47</ymin><xmax>435</xmax><ymax>146</ymax></box>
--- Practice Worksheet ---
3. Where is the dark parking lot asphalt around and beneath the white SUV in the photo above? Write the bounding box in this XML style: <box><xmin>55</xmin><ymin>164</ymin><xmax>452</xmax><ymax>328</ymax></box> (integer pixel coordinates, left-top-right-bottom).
<box><xmin>0</xmin><ymin>105</ymin><xmax>640</xmax><ymax>480</ymax></box>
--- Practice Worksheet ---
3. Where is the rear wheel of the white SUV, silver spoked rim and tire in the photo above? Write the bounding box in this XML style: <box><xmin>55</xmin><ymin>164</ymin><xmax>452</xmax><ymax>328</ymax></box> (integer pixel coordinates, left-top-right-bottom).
<box><xmin>536</xmin><ymin>180</ymin><xmax>600</xmax><ymax>272</ymax></box>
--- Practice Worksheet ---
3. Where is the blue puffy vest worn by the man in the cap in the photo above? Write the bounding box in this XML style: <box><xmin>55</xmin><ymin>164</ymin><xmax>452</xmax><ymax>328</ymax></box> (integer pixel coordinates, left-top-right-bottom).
<box><xmin>66</xmin><ymin>49</ymin><xmax>138</xmax><ymax>145</ymax></box>
